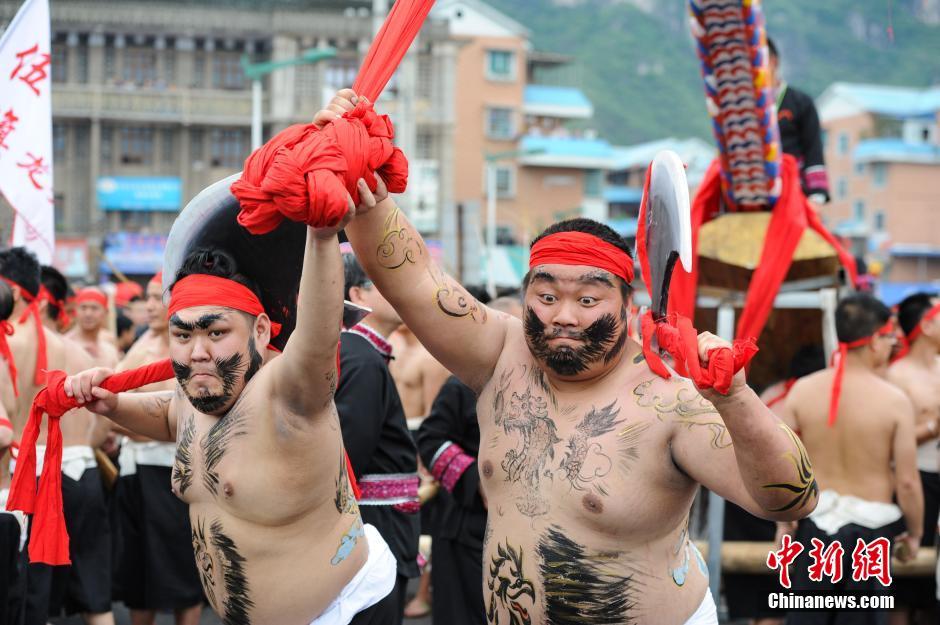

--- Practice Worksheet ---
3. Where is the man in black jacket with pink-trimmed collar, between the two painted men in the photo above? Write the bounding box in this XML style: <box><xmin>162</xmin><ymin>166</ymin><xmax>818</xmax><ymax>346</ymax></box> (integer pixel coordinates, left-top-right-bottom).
<box><xmin>335</xmin><ymin>254</ymin><xmax>420</xmax><ymax>623</ymax></box>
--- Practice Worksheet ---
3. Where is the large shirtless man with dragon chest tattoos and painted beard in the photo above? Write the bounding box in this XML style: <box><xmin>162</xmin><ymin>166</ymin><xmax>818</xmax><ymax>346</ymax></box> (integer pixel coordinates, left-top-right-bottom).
<box><xmin>320</xmin><ymin>90</ymin><xmax>816</xmax><ymax>625</ymax></box>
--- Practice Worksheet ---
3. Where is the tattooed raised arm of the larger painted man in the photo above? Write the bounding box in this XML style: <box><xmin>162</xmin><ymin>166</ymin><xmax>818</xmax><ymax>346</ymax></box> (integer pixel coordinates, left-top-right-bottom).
<box><xmin>324</xmin><ymin>90</ymin><xmax>510</xmax><ymax>391</ymax></box>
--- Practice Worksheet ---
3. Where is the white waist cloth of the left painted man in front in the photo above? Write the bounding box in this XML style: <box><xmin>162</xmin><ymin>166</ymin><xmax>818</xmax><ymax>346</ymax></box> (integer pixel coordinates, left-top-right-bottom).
<box><xmin>310</xmin><ymin>523</ymin><xmax>398</xmax><ymax>625</ymax></box>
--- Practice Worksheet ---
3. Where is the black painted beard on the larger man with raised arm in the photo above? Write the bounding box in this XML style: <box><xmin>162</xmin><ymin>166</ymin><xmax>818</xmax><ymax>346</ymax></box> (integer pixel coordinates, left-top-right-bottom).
<box><xmin>524</xmin><ymin>307</ymin><xmax>627</xmax><ymax>377</ymax></box>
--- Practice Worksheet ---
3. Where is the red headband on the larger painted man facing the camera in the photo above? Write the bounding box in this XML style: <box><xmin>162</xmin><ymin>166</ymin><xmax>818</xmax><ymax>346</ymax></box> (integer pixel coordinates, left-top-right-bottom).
<box><xmin>529</xmin><ymin>232</ymin><xmax>633</xmax><ymax>284</ymax></box>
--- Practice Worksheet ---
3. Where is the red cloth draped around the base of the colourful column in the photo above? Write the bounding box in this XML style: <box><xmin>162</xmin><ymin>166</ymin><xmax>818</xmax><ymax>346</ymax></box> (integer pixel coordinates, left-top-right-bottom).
<box><xmin>669</xmin><ymin>154</ymin><xmax>857</xmax><ymax>339</ymax></box>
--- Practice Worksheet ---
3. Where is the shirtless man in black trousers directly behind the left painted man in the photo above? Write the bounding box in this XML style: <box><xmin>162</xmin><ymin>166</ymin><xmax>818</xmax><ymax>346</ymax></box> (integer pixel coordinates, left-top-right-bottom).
<box><xmin>114</xmin><ymin>273</ymin><xmax>202</xmax><ymax>625</ymax></box>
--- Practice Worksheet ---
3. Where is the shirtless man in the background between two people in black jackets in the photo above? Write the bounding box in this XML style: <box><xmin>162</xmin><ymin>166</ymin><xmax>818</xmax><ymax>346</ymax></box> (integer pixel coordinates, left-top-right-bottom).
<box><xmin>388</xmin><ymin>325</ymin><xmax>450</xmax><ymax>430</ymax></box>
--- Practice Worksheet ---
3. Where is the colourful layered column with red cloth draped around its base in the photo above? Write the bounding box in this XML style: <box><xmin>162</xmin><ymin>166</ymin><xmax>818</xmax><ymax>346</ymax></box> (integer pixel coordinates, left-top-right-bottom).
<box><xmin>669</xmin><ymin>0</ymin><xmax>856</xmax><ymax>340</ymax></box>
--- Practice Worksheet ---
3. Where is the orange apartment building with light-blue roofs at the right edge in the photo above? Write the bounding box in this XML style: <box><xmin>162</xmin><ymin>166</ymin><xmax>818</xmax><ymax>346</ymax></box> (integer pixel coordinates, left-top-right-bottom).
<box><xmin>817</xmin><ymin>83</ymin><xmax>940</xmax><ymax>303</ymax></box>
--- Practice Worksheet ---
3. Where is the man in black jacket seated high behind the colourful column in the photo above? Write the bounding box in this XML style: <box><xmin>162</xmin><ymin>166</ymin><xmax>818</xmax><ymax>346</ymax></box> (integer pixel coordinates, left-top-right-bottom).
<box><xmin>767</xmin><ymin>38</ymin><xmax>829</xmax><ymax>204</ymax></box>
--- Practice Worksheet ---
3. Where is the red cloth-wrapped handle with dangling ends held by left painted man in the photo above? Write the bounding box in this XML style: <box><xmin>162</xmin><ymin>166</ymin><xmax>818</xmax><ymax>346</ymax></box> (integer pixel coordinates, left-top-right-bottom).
<box><xmin>7</xmin><ymin>358</ymin><xmax>174</xmax><ymax>566</ymax></box>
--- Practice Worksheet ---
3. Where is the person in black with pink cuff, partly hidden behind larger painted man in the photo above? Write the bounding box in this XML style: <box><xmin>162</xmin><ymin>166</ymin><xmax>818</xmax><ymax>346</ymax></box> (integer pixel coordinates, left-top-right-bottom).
<box><xmin>418</xmin><ymin>295</ymin><xmax>522</xmax><ymax>625</ymax></box>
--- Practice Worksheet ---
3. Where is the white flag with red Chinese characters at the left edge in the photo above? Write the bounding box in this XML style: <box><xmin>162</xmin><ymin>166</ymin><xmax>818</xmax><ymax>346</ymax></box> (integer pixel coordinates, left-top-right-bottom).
<box><xmin>0</xmin><ymin>0</ymin><xmax>55</xmax><ymax>265</ymax></box>
